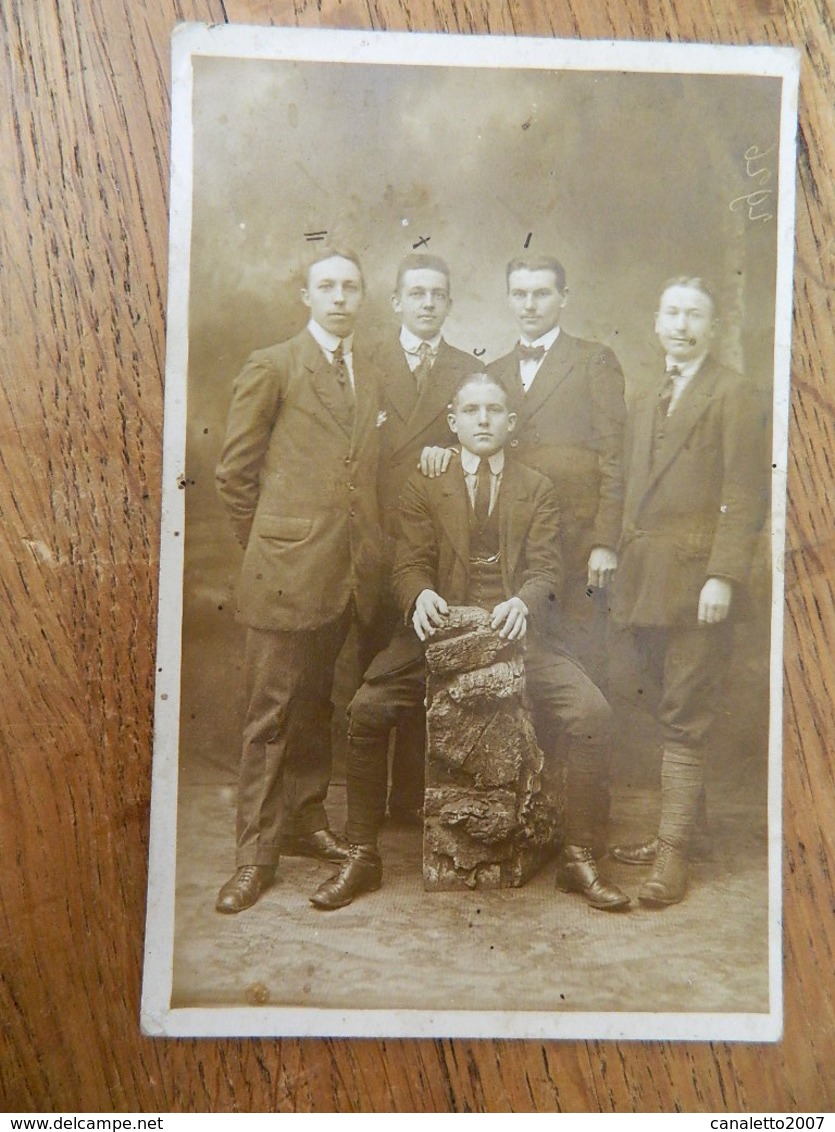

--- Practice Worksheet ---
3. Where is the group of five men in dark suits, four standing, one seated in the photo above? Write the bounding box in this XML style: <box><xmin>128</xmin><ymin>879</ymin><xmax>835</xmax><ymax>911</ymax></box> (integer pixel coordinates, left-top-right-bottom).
<box><xmin>216</xmin><ymin>248</ymin><xmax>768</xmax><ymax>912</ymax></box>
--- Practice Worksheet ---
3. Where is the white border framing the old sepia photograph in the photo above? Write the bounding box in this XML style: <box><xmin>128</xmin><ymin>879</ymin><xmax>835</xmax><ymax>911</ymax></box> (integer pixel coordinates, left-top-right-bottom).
<box><xmin>141</xmin><ymin>24</ymin><xmax>799</xmax><ymax>1041</ymax></box>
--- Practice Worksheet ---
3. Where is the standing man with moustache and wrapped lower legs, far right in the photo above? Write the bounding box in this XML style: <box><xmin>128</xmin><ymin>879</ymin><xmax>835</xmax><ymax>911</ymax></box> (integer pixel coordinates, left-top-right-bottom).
<box><xmin>612</xmin><ymin>276</ymin><xmax>771</xmax><ymax>906</ymax></box>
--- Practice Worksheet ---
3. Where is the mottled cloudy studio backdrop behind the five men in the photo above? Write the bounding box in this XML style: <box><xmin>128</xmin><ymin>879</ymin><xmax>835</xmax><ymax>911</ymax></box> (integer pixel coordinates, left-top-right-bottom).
<box><xmin>175</xmin><ymin>48</ymin><xmax>781</xmax><ymax>1010</ymax></box>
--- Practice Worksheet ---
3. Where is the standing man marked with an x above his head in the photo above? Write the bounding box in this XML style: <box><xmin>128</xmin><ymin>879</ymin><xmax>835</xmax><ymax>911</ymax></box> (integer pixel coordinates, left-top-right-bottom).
<box><xmin>365</xmin><ymin>254</ymin><xmax>477</xmax><ymax>822</ymax></box>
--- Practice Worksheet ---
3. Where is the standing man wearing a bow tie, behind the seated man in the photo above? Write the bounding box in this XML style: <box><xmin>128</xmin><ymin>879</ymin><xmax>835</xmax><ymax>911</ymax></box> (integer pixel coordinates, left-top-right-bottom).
<box><xmin>481</xmin><ymin>256</ymin><xmax>626</xmax><ymax>679</ymax></box>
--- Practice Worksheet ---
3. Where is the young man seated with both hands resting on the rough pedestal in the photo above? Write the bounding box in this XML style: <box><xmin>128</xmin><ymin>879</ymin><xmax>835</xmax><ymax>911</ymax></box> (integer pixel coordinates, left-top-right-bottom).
<box><xmin>310</xmin><ymin>374</ymin><xmax>629</xmax><ymax>911</ymax></box>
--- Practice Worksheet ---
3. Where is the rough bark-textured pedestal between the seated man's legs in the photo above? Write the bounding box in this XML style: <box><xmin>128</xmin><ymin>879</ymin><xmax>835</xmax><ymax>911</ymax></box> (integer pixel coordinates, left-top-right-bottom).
<box><xmin>423</xmin><ymin>607</ymin><xmax>562</xmax><ymax>889</ymax></box>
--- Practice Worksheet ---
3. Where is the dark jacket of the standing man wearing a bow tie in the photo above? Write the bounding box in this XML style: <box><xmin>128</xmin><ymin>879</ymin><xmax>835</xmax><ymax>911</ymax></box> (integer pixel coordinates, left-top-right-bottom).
<box><xmin>489</xmin><ymin>331</ymin><xmax>626</xmax><ymax>602</ymax></box>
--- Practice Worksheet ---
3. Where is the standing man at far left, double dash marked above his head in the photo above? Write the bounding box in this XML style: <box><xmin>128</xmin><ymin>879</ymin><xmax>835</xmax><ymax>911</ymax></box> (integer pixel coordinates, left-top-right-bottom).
<box><xmin>216</xmin><ymin>248</ymin><xmax>379</xmax><ymax>912</ymax></box>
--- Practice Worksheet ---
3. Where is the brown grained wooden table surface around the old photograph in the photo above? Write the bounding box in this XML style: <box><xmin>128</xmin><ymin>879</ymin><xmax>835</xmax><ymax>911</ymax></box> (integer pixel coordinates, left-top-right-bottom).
<box><xmin>0</xmin><ymin>0</ymin><xmax>835</xmax><ymax>1113</ymax></box>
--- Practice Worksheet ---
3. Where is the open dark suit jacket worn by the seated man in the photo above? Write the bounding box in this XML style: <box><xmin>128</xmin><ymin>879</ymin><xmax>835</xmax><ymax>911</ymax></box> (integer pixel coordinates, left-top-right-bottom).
<box><xmin>393</xmin><ymin>458</ymin><xmax>562</xmax><ymax>640</ymax></box>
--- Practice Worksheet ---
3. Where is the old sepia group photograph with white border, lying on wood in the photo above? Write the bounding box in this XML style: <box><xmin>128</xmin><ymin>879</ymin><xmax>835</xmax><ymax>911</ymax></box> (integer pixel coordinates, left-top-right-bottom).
<box><xmin>141</xmin><ymin>25</ymin><xmax>799</xmax><ymax>1041</ymax></box>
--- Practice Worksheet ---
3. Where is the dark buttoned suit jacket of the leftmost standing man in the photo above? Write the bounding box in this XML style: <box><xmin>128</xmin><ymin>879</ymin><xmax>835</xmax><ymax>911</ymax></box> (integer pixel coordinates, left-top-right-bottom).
<box><xmin>216</xmin><ymin>329</ymin><xmax>380</xmax><ymax>631</ymax></box>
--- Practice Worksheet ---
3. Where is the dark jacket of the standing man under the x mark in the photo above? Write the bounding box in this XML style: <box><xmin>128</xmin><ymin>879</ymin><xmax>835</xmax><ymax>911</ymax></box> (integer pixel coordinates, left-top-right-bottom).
<box><xmin>373</xmin><ymin>338</ymin><xmax>481</xmax><ymax>536</ymax></box>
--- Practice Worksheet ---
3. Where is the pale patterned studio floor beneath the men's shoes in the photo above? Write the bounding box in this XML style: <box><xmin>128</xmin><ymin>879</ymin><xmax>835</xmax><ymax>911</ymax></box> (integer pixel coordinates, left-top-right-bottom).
<box><xmin>172</xmin><ymin>770</ymin><xmax>768</xmax><ymax>1012</ymax></box>
